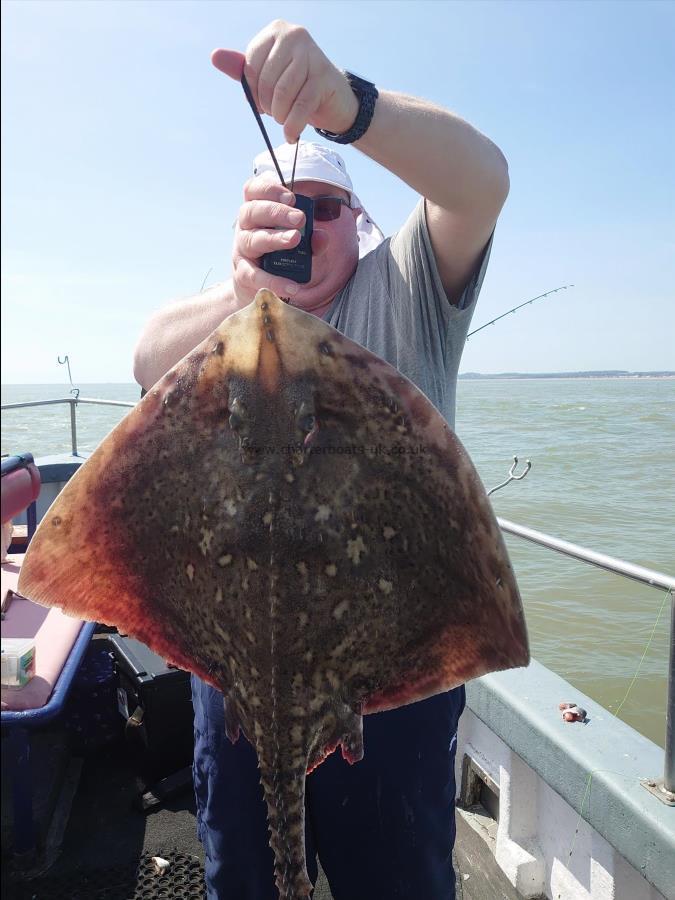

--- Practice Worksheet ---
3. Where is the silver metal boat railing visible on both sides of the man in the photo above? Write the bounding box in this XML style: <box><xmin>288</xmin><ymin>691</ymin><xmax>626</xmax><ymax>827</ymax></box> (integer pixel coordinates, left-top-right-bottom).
<box><xmin>2</xmin><ymin>395</ymin><xmax>675</xmax><ymax>804</ymax></box>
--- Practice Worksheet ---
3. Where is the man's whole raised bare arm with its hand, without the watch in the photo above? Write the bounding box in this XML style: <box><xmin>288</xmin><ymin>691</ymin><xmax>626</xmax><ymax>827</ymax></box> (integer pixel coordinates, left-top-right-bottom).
<box><xmin>211</xmin><ymin>19</ymin><xmax>509</xmax><ymax>303</ymax></box>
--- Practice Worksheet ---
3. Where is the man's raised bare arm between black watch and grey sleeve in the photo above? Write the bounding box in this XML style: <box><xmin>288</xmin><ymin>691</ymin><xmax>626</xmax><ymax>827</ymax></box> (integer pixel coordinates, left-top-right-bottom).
<box><xmin>354</xmin><ymin>91</ymin><xmax>509</xmax><ymax>303</ymax></box>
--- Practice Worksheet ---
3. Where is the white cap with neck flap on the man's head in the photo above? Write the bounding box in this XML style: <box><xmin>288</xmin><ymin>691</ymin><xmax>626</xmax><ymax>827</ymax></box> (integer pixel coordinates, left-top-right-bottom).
<box><xmin>253</xmin><ymin>141</ymin><xmax>384</xmax><ymax>258</ymax></box>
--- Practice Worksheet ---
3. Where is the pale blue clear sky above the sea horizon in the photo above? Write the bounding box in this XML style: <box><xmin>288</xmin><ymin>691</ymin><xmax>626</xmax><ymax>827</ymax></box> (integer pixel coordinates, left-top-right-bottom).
<box><xmin>2</xmin><ymin>0</ymin><xmax>675</xmax><ymax>383</ymax></box>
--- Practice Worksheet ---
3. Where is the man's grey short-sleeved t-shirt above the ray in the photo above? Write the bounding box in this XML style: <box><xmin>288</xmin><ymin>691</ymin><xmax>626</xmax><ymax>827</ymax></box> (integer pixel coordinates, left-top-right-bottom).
<box><xmin>323</xmin><ymin>199</ymin><xmax>492</xmax><ymax>428</ymax></box>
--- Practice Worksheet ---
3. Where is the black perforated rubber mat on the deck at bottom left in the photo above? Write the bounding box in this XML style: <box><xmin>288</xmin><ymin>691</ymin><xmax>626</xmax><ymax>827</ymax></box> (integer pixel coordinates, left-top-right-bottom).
<box><xmin>3</xmin><ymin>852</ymin><xmax>206</xmax><ymax>900</ymax></box>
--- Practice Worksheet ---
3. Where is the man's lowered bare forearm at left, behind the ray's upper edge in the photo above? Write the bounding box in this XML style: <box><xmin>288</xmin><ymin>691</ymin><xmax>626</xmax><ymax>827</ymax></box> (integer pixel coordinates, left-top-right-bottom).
<box><xmin>134</xmin><ymin>280</ymin><xmax>241</xmax><ymax>391</ymax></box>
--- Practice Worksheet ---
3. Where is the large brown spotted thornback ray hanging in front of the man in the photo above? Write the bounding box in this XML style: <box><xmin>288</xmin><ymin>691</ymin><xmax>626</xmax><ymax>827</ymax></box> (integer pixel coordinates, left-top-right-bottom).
<box><xmin>19</xmin><ymin>291</ymin><xmax>529</xmax><ymax>900</ymax></box>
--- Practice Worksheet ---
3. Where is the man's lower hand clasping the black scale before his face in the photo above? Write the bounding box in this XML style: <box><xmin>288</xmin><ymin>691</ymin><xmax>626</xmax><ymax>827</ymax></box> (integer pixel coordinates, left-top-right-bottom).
<box><xmin>232</xmin><ymin>175</ymin><xmax>326</xmax><ymax>305</ymax></box>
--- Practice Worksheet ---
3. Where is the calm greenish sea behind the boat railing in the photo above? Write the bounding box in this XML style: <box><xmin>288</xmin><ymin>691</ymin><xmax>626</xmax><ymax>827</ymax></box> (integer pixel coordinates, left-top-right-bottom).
<box><xmin>2</xmin><ymin>378</ymin><xmax>675</xmax><ymax>746</ymax></box>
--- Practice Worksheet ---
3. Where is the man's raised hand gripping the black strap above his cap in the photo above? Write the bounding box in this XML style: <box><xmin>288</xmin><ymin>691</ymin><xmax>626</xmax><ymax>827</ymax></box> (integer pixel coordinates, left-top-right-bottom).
<box><xmin>211</xmin><ymin>19</ymin><xmax>359</xmax><ymax>144</ymax></box>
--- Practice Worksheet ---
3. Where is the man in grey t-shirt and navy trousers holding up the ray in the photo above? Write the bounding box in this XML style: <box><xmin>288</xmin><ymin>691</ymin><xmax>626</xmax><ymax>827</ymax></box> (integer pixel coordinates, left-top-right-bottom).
<box><xmin>135</xmin><ymin>21</ymin><xmax>508</xmax><ymax>900</ymax></box>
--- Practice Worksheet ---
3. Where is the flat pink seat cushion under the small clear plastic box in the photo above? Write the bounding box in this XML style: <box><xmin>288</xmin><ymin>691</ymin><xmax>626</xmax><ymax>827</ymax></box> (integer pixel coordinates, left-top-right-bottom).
<box><xmin>2</xmin><ymin>553</ymin><xmax>82</xmax><ymax>710</ymax></box>
